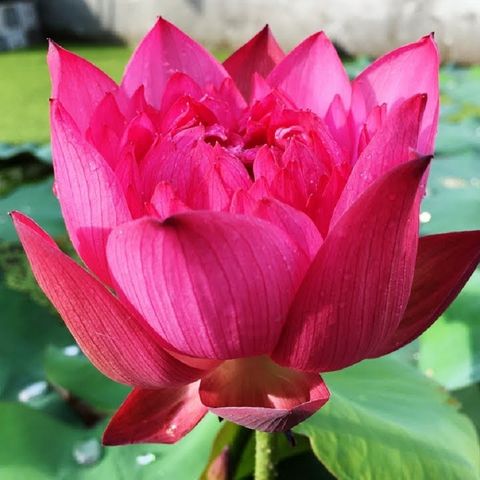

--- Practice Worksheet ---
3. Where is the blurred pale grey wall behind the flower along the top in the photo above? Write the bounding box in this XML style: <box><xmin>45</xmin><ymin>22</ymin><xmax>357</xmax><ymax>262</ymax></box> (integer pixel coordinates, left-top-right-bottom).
<box><xmin>38</xmin><ymin>0</ymin><xmax>480</xmax><ymax>63</ymax></box>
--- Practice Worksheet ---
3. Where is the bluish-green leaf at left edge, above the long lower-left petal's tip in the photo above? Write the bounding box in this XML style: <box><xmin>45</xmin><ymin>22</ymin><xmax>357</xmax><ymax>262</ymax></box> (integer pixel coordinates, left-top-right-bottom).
<box><xmin>0</xmin><ymin>177</ymin><xmax>65</xmax><ymax>241</ymax></box>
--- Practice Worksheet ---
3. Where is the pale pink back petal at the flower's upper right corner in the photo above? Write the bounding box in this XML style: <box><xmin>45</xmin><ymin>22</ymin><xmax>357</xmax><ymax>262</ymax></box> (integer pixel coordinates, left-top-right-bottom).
<box><xmin>352</xmin><ymin>35</ymin><xmax>439</xmax><ymax>155</ymax></box>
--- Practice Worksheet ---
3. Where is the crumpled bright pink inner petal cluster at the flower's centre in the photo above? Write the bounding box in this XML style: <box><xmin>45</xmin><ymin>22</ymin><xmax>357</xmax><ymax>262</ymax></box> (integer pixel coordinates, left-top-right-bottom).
<box><xmin>87</xmin><ymin>73</ymin><xmax>350</xmax><ymax>235</ymax></box>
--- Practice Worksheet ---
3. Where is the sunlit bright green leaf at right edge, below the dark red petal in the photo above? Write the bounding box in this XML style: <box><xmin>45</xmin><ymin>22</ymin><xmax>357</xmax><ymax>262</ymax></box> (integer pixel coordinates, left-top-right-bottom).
<box><xmin>418</xmin><ymin>271</ymin><xmax>480</xmax><ymax>389</ymax></box>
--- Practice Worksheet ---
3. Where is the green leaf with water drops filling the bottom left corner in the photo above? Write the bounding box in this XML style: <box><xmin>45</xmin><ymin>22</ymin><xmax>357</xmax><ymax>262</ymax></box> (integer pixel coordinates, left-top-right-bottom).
<box><xmin>0</xmin><ymin>403</ymin><xmax>219</xmax><ymax>480</ymax></box>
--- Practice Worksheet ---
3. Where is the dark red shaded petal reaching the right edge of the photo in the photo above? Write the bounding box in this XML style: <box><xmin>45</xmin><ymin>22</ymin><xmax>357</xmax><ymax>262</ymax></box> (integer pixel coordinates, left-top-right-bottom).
<box><xmin>373</xmin><ymin>230</ymin><xmax>480</xmax><ymax>357</ymax></box>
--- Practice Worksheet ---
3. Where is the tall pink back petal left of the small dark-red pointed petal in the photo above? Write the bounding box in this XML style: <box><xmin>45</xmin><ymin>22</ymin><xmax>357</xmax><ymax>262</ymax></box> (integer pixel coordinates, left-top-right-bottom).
<box><xmin>121</xmin><ymin>18</ymin><xmax>228</xmax><ymax>107</ymax></box>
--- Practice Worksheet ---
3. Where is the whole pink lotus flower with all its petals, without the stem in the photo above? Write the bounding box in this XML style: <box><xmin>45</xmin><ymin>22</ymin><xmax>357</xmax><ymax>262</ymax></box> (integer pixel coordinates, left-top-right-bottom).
<box><xmin>13</xmin><ymin>20</ymin><xmax>480</xmax><ymax>444</ymax></box>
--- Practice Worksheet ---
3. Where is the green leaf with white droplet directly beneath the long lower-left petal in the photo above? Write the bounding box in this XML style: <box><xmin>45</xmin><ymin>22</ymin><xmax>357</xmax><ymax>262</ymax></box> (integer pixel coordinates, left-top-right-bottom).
<box><xmin>44</xmin><ymin>345</ymin><xmax>130</xmax><ymax>413</ymax></box>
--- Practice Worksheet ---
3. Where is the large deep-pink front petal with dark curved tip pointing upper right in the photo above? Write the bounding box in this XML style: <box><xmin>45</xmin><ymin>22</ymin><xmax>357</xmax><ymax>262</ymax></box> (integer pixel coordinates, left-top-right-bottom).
<box><xmin>273</xmin><ymin>159</ymin><xmax>428</xmax><ymax>371</ymax></box>
